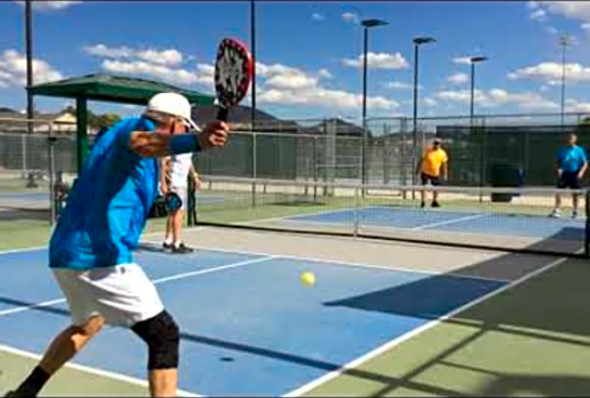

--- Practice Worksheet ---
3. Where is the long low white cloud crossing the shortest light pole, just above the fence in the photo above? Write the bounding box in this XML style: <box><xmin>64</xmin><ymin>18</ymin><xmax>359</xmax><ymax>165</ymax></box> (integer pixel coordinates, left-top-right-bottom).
<box><xmin>435</xmin><ymin>88</ymin><xmax>559</xmax><ymax>111</ymax></box>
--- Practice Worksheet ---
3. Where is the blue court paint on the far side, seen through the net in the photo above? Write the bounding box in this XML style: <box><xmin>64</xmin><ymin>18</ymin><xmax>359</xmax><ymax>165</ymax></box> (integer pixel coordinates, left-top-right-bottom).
<box><xmin>285</xmin><ymin>206</ymin><xmax>585</xmax><ymax>242</ymax></box>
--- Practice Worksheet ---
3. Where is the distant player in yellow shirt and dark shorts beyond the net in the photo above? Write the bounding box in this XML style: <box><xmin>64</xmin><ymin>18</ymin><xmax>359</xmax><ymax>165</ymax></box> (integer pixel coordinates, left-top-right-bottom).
<box><xmin>416</xmin><ymin>138</ymin><xmax>449</xmax><ymax>207</ymax></box>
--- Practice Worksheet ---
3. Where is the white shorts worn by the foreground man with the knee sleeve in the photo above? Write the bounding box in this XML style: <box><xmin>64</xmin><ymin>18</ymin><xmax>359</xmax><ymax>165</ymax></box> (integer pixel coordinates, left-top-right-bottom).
<box><xmin>53</xmin><ymin>264</ymin><xmax>164</xmax><ymax>327</ymax></box>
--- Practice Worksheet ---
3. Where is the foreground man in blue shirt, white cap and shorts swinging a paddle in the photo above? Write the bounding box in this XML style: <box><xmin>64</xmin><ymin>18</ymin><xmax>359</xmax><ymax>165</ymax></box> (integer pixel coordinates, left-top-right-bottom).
<box><xmin>9</xmin><ymin>93</ymin><xmax>228</xmax><ymax>397</ymax></box>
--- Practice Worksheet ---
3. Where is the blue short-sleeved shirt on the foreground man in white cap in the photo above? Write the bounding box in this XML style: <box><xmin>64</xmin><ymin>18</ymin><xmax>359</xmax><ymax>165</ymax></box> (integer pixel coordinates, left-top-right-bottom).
<box><xmin>49</xmin><ymin>118</ymin><xmax>159</xmax><ymax>270</ymax></box>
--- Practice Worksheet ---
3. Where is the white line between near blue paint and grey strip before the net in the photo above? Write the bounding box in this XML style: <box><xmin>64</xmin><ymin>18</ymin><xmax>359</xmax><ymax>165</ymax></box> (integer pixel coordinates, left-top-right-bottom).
<box><xmin>144</xmin><ymin>241</ymin><xmax>512</xmax><ymax>283</ymax></box>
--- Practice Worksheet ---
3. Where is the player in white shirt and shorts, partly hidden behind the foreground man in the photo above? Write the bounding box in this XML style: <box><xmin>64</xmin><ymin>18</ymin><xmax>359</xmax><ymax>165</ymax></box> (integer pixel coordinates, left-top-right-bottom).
<box><xmin>160</xmin><ymin>153</ymin><xmax>201</xmax><ymax>253</ymax></box>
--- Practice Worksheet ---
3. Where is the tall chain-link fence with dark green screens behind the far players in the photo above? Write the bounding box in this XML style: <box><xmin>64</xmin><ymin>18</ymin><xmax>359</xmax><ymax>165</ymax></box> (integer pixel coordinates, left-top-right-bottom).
<box><xmin>196</xmin><ymin>113</ymin><xmax>590</xmax><ymax>190</ymax></box>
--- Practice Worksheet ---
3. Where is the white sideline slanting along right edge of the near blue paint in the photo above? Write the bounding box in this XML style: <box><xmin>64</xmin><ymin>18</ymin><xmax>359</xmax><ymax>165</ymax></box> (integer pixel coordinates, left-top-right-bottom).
<box><xmin>283</xmin><ymin>258</ymin><xmax>567</xmax><ymax>397</ymax></box>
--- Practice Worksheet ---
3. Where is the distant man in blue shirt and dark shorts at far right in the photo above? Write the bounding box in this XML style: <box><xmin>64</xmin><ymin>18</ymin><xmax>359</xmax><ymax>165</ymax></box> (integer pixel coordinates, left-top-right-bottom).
<box><xmin>551</xmin><ymin>133</ymin><xmax>588</xmax><ymax>218</ymax></box>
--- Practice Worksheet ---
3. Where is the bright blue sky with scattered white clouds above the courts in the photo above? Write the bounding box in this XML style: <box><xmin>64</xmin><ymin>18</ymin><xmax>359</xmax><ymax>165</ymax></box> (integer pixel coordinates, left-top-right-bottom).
<box><xmin>0</xmin><ymin>1</ymin><xmax>590</xmax><ymax>118</ymax></box>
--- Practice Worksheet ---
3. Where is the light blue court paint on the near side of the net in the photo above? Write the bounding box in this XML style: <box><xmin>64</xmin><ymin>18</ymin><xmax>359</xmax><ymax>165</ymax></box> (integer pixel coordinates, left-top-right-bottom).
<box><xmin>0</xmin><ymin>252</ymin><xmax>504</xmax><ymax>396</ymax></box>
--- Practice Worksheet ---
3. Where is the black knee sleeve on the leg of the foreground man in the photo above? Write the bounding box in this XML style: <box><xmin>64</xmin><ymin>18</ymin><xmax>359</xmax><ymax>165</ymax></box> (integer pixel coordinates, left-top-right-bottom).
<box><xmin>131</xmin><ymin>311</ymin><xmax>180</xmax><ymax>370</ymax></box>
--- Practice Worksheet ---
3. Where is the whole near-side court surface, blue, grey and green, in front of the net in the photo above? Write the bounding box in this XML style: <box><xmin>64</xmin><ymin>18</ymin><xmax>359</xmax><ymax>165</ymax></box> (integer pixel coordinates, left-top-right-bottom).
<box><xmin>0</xmin><ymin>227</ymin><xmax>586</xmax><ymax>396</ymax></box>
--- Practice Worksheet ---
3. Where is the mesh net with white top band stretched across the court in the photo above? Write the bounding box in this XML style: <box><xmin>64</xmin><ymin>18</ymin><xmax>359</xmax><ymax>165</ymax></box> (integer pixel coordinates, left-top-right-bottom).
<box><xmin>195</xmin><ymin>176</ymin><xmax>590</xmax><ymax>258</ymax></box>
